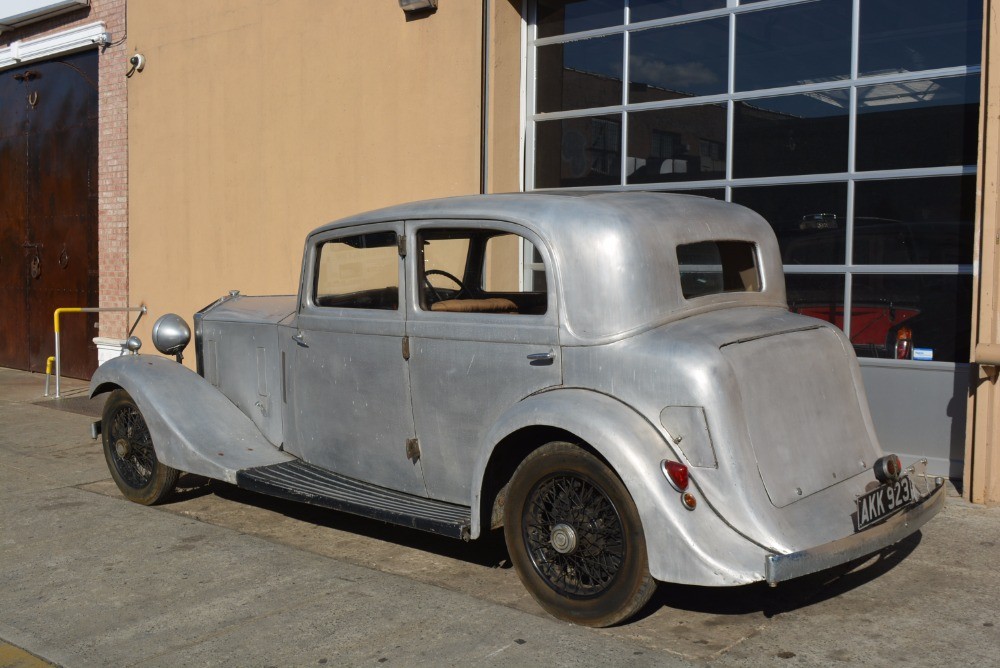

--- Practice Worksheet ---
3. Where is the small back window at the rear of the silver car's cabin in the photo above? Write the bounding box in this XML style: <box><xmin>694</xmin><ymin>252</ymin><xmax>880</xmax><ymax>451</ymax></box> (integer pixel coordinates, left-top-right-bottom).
<box><xmin>677</xmin><ymin>241</ymin><xmax>761</xmax><ymax>299</ymax></box>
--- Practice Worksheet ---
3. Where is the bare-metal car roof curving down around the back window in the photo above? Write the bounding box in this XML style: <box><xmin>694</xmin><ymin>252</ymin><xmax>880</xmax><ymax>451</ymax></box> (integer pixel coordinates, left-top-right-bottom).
<box><xmin>312</xmin><ymin>190</ymin><xmax>785</xmax><ymax>344</ymax></box>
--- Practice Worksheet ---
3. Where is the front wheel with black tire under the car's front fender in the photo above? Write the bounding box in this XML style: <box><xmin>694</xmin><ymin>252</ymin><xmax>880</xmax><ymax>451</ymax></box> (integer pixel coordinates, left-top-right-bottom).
<box><xmin>101</xmin><ymin>390</ymin><xmax>178</xmax><ymax>506</ymax></box>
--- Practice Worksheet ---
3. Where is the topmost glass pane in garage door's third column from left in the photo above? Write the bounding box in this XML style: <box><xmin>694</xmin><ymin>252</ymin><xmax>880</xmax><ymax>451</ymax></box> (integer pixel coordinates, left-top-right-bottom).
<box><xmin>736</xmin><ymin>0</ymin><xmax>851</xmax><ymax>91</ymax></box>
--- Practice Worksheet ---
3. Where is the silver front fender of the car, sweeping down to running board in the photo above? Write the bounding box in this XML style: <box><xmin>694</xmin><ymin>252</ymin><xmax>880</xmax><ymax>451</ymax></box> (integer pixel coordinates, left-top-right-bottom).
<box><xmin>90</xmin><ymin>355</ymin><xmax>294</xmax><ymax>483</ymax></box>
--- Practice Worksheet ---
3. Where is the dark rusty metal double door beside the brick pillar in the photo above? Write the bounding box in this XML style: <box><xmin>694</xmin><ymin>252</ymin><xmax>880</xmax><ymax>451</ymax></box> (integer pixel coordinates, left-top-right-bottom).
<box><xmin>0</xmin><ymin>51</ymin><xmax>98</xmax><ymax>378</ymax></box>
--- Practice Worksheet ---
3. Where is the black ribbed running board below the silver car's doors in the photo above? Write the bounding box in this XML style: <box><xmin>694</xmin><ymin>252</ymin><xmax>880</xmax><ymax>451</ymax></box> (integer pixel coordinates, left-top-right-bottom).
<box><xmin>236</xmin><ymin>460</ymin><xmax>472</xmax><ymax>540</ymax></box>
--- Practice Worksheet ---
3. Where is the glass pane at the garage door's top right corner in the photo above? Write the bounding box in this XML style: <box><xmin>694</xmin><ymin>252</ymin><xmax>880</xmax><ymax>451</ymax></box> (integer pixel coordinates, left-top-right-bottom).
<box><xmin>858</xmin><ymin>0</ymin><xmax>983</xmax><ymax>74</ymax></box>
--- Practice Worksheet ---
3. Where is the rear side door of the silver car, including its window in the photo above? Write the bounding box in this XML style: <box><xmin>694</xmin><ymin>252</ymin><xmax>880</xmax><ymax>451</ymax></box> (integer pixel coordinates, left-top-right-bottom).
<box><xmin>407</xmin><ymin>221</ymin><xmax>562</xmax><ymax>504</ymax></box>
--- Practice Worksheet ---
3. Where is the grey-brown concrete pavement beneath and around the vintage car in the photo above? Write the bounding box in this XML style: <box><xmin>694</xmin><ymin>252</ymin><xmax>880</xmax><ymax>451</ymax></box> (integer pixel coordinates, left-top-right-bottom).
<box><xmin>0</xmin><ymin>369</ymin><xmax>1000</xmax><ymax>666</ymax></box>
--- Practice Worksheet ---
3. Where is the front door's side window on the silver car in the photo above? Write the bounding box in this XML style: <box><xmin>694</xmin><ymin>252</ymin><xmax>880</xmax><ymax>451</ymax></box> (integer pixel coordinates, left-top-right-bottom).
<box><xmin>313</xmin><ymin>231</ymin><xmax>399</xmax><ymax>311</ymax></box>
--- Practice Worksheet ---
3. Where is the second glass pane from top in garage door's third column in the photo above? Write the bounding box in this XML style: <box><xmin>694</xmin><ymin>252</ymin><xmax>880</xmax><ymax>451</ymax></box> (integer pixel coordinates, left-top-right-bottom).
<box><xmin>733</xmin><ymin>90</ymin><xmax>850</xmax><ymax>178</ymax></box>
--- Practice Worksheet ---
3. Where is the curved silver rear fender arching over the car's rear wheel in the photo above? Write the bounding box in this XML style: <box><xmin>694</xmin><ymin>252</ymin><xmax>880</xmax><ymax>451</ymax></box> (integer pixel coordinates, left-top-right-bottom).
<box><xmin>471</xmin><ymin>389</ymin><xmax>770</xmax><ymax>586</ymax></box>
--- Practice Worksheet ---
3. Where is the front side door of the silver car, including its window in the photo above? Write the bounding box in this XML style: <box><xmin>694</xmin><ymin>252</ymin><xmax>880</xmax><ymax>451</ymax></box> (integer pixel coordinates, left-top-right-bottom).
<box><xmin>286</xmin><ymin>223</ymin><xmax>426</xmax><ymax>496</ymax></box>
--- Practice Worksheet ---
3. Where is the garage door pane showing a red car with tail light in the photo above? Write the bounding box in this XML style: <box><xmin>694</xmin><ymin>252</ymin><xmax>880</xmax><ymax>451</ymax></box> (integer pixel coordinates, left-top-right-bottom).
<box><xmin>851</xmin><ymin>274</ymin><xmax>972</xmax><ymax>362</ymax></box>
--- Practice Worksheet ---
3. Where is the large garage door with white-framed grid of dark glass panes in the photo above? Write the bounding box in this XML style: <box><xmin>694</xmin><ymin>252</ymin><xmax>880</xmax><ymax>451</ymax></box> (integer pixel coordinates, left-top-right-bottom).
<box><xmin>526</xmin><ymin>0</ymin><xmax>982</xmax><ymax>477</ymax></box>
